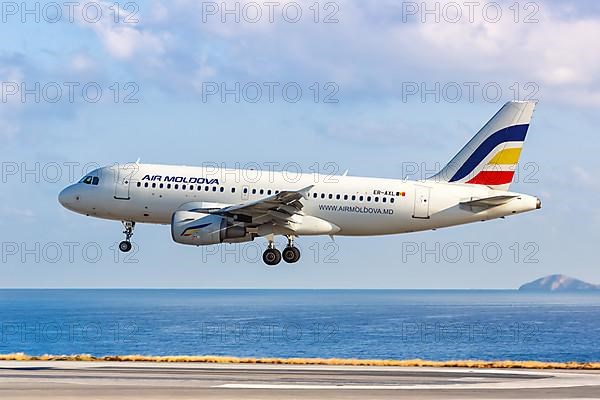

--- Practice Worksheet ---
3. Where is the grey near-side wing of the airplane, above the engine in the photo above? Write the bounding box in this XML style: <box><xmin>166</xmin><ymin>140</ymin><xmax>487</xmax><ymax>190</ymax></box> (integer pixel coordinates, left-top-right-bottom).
<box><xmin>190</xmin><ymin>185</ymin><xmax>313</xmax><ymax>226</ymax></box>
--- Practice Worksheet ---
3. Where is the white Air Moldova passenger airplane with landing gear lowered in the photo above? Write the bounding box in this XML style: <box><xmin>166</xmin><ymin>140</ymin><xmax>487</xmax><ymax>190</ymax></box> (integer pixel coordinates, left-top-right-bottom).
<box><xmin>58</xmin><ymin>101</ymin><xmax>541</xmax><ymax>266</ymax></box>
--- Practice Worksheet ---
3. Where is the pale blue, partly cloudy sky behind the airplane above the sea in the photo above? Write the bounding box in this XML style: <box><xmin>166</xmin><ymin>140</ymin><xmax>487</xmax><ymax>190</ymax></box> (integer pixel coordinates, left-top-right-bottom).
<box><xmin>0</xmin><ymin>0</ymin><xmax>600</xmax><ymax>288</ymax></box>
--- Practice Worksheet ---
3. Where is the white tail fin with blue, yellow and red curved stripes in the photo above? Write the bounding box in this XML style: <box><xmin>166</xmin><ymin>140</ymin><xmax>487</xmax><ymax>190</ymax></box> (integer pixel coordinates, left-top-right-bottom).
<box><xmin>429</xmin><ymin>101</ymin><xmax>536</xmax><ymax>190</ymax></box>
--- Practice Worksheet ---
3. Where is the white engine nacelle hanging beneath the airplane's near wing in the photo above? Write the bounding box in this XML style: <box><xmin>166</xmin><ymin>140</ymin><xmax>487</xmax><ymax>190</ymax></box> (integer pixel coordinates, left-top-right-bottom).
<box><xmin>171</xmin><ymin>211</ymin><xmax>254</xmax><ymax>246</ymax></box>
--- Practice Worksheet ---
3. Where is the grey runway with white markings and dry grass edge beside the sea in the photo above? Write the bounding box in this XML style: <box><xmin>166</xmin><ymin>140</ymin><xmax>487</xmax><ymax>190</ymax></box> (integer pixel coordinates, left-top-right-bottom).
<box><xmin>0</xmin><ymin>361</ymin><xmax>600</xmax><ymax>399</ymax></box>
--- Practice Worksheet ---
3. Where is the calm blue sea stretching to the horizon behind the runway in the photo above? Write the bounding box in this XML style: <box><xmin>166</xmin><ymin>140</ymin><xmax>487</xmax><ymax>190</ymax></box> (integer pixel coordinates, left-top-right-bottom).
<box><xmin>0</xmin><ymin>289</ymin><xmax>600</xmax><ymax>362</ymax></box>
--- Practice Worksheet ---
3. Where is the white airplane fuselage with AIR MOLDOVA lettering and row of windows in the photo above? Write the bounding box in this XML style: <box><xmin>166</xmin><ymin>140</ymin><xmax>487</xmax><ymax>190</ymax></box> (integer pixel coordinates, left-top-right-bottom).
<box><xmin>59</xmin><ymin>164</ymin><xmax>539</xmax><ymax>236</ymax></box>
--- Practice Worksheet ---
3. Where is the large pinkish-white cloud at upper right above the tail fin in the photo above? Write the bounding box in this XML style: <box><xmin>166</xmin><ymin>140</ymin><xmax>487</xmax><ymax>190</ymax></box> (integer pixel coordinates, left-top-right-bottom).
<box><xmin>360</xmin><ymin>4</ymin><xmax>600</xmax><ymax>104</ymax></box>
